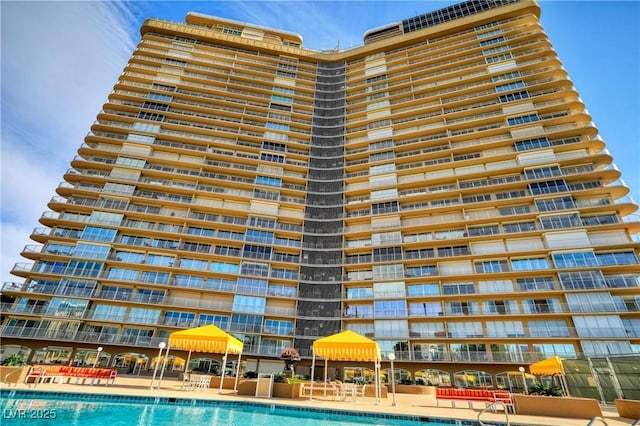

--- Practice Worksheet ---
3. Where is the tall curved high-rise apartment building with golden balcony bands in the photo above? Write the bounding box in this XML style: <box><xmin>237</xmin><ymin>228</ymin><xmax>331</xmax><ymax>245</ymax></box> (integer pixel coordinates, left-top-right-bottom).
<box><xmin>1</xmin><ymin>0</ymin><xmax>640</xmax><ymax>380</ymax></box>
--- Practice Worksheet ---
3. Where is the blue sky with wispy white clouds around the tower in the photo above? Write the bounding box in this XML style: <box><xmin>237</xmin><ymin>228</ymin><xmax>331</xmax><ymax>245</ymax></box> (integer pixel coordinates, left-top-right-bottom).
<box><xmin>0</xmin><ymin>0</ymin><xmax>640</xmax><ymax>282</ymax></box>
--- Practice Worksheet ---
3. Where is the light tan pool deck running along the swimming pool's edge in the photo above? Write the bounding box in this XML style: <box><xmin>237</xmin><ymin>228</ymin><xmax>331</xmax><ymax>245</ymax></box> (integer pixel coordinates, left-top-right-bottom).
<box><xmin>0</xmin><ymin>376</ymin><xmax>632</xmax><ymax>426</ymax></box>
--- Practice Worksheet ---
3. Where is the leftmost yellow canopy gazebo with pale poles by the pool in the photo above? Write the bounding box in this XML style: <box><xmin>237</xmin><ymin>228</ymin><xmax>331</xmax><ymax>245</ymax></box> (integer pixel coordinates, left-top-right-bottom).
<box><xmin>161</xmin><ymin>324</ymin><xmax>243</xmax><ymax>393</ymax></box>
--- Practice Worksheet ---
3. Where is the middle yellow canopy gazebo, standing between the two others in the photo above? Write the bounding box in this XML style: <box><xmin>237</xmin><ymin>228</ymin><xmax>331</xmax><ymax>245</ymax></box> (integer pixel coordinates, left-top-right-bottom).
<box><xmin>309</xmin><ymin>330</ymin><xmax>382</xmax><ymax>402</ymax></box>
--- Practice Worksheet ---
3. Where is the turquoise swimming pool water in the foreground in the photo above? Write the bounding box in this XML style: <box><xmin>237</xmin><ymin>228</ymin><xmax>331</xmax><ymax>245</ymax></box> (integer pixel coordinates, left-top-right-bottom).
<box><xmin>0</xmin><ymin>389</ymin><xmax>500</xmax><ymax>426</ymax></box>
